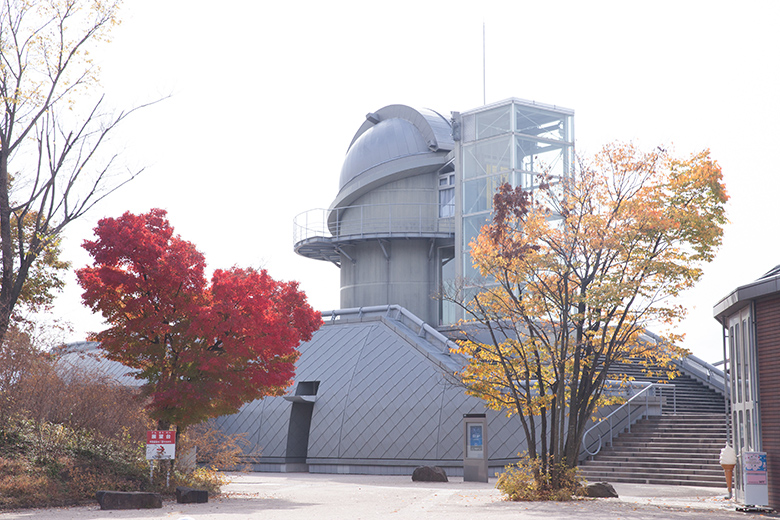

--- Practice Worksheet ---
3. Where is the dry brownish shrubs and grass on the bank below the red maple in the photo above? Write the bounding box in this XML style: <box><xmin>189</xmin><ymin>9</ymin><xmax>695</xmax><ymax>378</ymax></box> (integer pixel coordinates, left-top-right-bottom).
<box><xmin>0</xmin><ymin>334</ymin><xmax>243</xmax><ymax>509</ymax></box>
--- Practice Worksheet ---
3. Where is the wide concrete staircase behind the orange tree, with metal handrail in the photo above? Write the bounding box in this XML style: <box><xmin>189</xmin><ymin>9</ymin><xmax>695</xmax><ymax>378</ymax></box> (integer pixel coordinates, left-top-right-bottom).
<box><xmin>580</xmin><ymin>367</ymin><xmax>726</xmax><ymax>488</ymax></box>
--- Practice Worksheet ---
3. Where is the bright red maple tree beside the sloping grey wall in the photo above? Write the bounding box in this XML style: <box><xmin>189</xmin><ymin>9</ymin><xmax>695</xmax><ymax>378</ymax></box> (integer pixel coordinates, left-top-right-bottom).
<box><xmin>76</xmin><ymin>209</ymin><xmax>322</xmax><ymax>429</ymax></box>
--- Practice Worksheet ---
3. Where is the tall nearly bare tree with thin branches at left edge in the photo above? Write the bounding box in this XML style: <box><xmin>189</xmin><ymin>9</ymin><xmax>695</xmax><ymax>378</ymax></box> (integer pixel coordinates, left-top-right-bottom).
<box><xmin>0</xmin><ymin>0</ymin><xmax>159</xmax><ymax>343</ymax></box>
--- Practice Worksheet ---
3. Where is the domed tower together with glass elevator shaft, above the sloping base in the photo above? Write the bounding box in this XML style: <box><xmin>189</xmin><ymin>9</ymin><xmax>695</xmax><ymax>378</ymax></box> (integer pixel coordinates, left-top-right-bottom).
<box><xmin>294</xmin><ymin>99</ymin><xmax>574</xmax><ymax>326</ymax></box>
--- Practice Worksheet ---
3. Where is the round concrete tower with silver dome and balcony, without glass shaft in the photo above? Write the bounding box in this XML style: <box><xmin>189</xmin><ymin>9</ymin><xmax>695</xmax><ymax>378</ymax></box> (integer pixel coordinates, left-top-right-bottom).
<box><xmin>295</xmin><ymin>105</ymin><xmax>455</xmax><ymax>325</ymax></box>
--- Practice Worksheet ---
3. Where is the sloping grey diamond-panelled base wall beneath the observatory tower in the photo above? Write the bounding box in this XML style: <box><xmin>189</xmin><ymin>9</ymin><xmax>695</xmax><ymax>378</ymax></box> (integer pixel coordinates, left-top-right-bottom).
<box><xmin>217</xmin><ymin>312</ymin><xmax>525</xmax><ymax>476</ymax></box>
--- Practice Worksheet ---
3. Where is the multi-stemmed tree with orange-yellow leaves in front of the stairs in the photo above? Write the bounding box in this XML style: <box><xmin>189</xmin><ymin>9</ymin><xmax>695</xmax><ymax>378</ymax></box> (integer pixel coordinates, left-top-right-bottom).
<box><xmin>445</xmin><ymin>143</ymin><xmax>728</xmax><ymax>484</ymax></box>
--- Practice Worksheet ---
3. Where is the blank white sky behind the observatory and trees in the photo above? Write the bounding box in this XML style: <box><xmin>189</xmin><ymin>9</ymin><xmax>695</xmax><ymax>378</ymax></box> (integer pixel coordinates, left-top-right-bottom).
<box><xmin>50</xmin><ymin>0</ymin><xmax>780</xmax><ymax>361</ymax></box>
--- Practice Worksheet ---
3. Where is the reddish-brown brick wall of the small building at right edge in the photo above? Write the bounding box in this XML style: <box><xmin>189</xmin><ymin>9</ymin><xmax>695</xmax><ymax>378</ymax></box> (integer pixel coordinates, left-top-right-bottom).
<box><xmin>755</xmin><ymin>296</ymin><xmax>780</xmax><ymax>509</ymax></box>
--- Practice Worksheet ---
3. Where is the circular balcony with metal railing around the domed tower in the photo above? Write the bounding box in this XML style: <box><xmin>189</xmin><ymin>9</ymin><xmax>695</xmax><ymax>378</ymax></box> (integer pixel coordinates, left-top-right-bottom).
<box><xmin>293</xmin><ymin>204</ymin><xmax>455</xmax><ymax>244</ymax></box>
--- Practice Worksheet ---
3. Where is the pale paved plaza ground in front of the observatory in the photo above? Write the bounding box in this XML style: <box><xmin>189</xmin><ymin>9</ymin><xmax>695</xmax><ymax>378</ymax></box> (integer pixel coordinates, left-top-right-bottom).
<box><xmin>0</xmin><ymin>473</ymin><xmax>780</xmax><ymax>520</ymax></box>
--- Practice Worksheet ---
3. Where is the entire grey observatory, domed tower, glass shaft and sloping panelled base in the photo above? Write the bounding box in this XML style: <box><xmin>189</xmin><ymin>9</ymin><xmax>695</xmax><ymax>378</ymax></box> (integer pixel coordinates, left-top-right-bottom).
<box><xmin>210</xmin><ymin>99</ymin><xmax>574</xmax><ymax>475</ymax></box>
